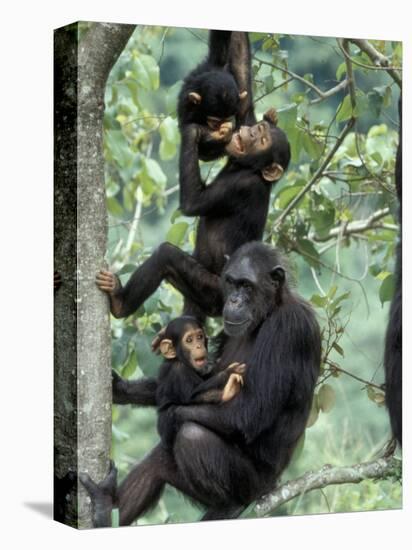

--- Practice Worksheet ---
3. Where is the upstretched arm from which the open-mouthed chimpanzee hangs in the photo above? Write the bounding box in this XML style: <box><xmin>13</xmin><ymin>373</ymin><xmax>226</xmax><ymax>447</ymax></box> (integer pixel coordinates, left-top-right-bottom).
<box><xmin>229</xmin><ymin>31</ymin><xmax>256</xmax><ymax>128</ymax></box>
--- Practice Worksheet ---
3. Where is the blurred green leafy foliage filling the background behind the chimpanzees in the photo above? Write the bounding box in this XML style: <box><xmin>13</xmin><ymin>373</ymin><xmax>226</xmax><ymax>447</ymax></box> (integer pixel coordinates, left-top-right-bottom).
<box><xmin>96</xmin><ymin>27</ymin><xmax>402</xmax><ymax>523</ymax></box>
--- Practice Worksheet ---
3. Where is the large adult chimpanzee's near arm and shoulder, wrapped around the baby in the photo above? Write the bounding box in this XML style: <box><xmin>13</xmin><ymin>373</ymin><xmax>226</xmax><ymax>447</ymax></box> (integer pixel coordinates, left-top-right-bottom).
<box><xmin>175</xmin><ymin>302</ymin><xmax>321</xmax><ymax>442</ymax></box>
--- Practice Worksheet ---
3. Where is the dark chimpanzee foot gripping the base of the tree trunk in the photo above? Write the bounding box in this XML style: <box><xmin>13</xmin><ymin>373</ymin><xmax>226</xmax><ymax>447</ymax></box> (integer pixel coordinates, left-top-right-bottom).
<box><xmin>79</xmin><ymin>461</ymin><xmax>117</xmax><ymax>527</ymax></box>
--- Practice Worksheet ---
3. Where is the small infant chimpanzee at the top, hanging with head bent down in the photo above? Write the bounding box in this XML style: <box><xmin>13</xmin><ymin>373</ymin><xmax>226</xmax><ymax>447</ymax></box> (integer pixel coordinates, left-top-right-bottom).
<box><xmin>177</xmin><ymin>31</ymin><xmax>247</xmax><ymax>160</ymax></box>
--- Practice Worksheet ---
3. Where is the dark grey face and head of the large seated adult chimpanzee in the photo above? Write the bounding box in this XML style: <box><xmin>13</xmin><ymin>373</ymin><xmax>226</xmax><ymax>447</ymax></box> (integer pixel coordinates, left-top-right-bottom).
<box><xmin>222</xmin><ymin>253</ymin><xmax>285</xmax><ymax>337</ymax></box>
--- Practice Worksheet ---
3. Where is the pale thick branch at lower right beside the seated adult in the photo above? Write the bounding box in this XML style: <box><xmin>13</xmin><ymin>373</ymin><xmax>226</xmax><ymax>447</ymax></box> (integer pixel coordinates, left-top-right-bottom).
<box><xmin>255</xmin><ymin>455</ymin><xmax>400</xmax><ymax>517</ymax></box>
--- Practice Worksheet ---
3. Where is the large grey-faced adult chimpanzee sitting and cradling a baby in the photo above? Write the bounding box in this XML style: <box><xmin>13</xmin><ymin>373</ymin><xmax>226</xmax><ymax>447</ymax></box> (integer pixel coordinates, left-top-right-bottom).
<box><xmin>82</xmin><ymin>242</ymin><xmax>321</xmax><ymax>526</ymax></box>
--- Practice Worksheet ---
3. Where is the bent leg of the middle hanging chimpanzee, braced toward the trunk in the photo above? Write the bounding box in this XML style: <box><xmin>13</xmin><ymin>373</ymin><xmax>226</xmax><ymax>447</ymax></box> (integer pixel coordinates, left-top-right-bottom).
<box><xmin>114</xmin><ymin>243</ymin><xmax>223</xmax><ymax>317</ymax></box>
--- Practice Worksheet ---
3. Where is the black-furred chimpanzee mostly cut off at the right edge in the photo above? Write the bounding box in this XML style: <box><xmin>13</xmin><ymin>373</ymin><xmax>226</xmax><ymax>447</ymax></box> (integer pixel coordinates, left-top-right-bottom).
<box><xmin>384</xmin><ymin>98</ymin><xmax>402</xmax><ymax>445</ymax></box>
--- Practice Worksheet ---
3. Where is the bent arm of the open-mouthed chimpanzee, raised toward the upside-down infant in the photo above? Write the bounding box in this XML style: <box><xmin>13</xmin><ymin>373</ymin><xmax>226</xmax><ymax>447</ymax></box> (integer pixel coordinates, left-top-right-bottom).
<box><xmin>179</xmin><ymin>124</ymin><xmax>254</xmax><ymax>216</ymax></box>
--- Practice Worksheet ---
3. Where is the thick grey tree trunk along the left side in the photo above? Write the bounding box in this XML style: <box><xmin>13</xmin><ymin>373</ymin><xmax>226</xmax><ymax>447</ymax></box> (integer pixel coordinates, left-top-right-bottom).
<box><xmin>54</xmin><ymin>23</ymin><xmax>134</xmax><ymax>528</ymax></box>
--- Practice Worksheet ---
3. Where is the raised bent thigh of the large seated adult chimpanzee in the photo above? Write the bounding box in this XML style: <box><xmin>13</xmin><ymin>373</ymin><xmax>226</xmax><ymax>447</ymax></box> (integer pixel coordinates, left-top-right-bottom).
<box><xmin>173</xmin><ymin>422</ymin><xmax>260</xmax><ymax>519</ymax></box>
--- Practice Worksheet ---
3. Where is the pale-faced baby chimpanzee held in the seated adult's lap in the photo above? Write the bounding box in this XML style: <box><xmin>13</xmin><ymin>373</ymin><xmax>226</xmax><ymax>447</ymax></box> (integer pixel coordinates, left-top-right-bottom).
<box><xmin>156</xmin><ymin>316</ymin><xmax>245</xmax><ymax>446</ymax></box>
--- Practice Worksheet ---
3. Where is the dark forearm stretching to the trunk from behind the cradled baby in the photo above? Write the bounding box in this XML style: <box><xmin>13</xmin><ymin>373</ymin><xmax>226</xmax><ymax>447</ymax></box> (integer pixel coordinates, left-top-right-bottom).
<box><xmin>112</xmin><ymin>370</ymin><xmax>157</xmax><ymax>407</ymax></box>
